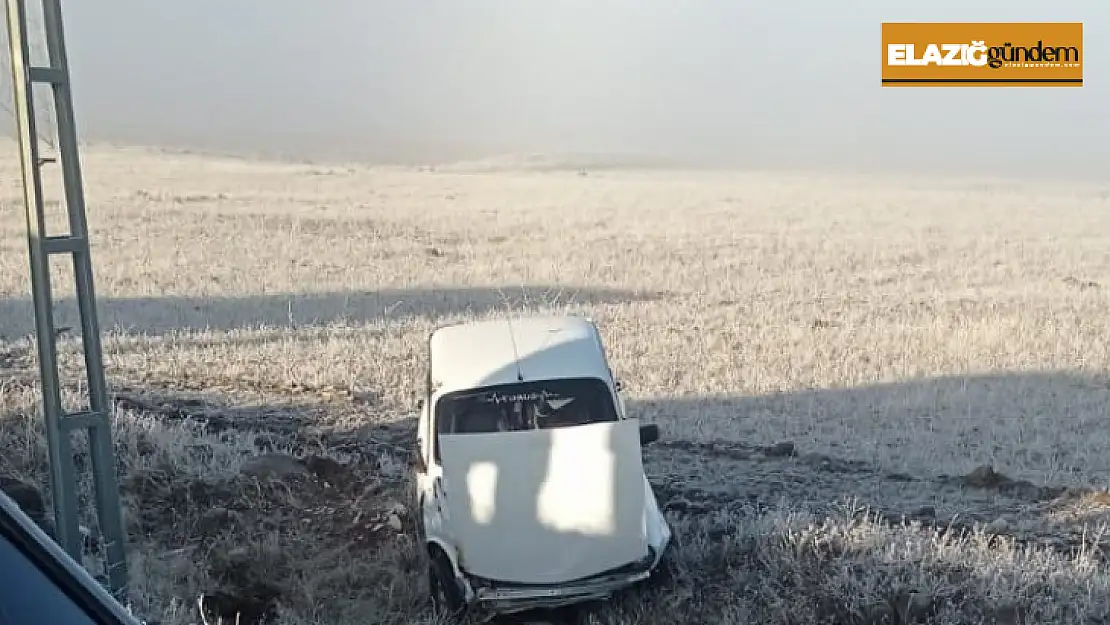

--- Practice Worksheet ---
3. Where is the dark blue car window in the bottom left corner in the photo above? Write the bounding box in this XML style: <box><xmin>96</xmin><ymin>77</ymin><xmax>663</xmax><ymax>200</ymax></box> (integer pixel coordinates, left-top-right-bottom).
<box><xmin>0</xmin><ymin>534</ymin><xmax>104</xmax><ymax>625</ymax></box>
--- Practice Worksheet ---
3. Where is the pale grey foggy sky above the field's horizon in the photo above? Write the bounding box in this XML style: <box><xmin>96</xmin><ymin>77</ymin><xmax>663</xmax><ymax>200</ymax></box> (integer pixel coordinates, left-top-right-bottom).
<box><xmin>4</xmin><ymin>0</ymin><xmax>1110</xmax><ymax>177</ymax></box>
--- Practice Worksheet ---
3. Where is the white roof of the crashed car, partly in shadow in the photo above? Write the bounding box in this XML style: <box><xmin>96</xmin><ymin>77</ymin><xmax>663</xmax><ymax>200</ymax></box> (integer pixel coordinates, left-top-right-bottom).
<box><xmin>430</xmin><ymin>315</ymin><xmax>612</xmax><ymax>394</ymax></box>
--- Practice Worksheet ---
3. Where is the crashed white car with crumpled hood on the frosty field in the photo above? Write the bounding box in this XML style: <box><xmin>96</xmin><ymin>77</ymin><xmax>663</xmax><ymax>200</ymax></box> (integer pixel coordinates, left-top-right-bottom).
<box><xmin>413</xmin><ymin>315</ymin><xmax>672</xmax><ymax>618</ymax></box>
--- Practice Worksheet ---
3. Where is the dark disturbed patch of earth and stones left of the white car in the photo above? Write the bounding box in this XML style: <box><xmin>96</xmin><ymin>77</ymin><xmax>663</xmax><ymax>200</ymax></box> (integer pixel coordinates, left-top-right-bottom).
<box><xmin>121</xmin><ymin>453</ymin><xmax>413</xmax><ymax>623</ymax></box>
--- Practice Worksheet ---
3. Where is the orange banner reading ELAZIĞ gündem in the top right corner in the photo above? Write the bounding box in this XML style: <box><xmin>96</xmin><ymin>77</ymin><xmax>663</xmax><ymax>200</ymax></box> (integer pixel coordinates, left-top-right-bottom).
<box><xmin>882</xmin><ymin>22</ymin><xmax>1083</xmax><ymax>87</ymax></box>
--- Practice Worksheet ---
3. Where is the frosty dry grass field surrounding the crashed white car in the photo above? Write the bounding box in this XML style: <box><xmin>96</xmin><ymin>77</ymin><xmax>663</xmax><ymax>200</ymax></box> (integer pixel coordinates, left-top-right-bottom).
<box><xmin>0</xmin><ymin>139</ymin><xmax>1110</xmax><ymax>625</ymax></box>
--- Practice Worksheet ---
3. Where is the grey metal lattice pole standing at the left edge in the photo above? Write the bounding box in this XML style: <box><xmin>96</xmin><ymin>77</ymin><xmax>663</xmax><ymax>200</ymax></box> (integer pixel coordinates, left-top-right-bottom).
<box><xmin>6</xmin><ymin>0</ymin><xmax>127</xmax><ymax>596</ymax></box>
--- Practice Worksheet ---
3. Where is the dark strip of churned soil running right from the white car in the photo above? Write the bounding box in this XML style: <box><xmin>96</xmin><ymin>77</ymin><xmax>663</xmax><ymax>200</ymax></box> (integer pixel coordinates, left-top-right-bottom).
<box><xmin>644</xmin><ymin>441</ymin><xmax>1110</xmax><ymax>560</ymax></box>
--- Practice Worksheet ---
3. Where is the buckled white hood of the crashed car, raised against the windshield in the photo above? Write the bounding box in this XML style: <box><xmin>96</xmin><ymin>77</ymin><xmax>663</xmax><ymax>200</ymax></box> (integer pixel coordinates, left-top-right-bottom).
<box><xmin>440</xmin><ymin>420</ymin><xmax>648</xmax><ymax>584</ymax></box>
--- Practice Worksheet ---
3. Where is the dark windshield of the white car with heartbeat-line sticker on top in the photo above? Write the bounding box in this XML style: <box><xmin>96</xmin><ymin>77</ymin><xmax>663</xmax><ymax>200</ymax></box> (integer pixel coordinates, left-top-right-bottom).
<box><xmin>435</xmin><ymin>379</ymin><xmax>617</xmax><ymax>434</ymax></box>
